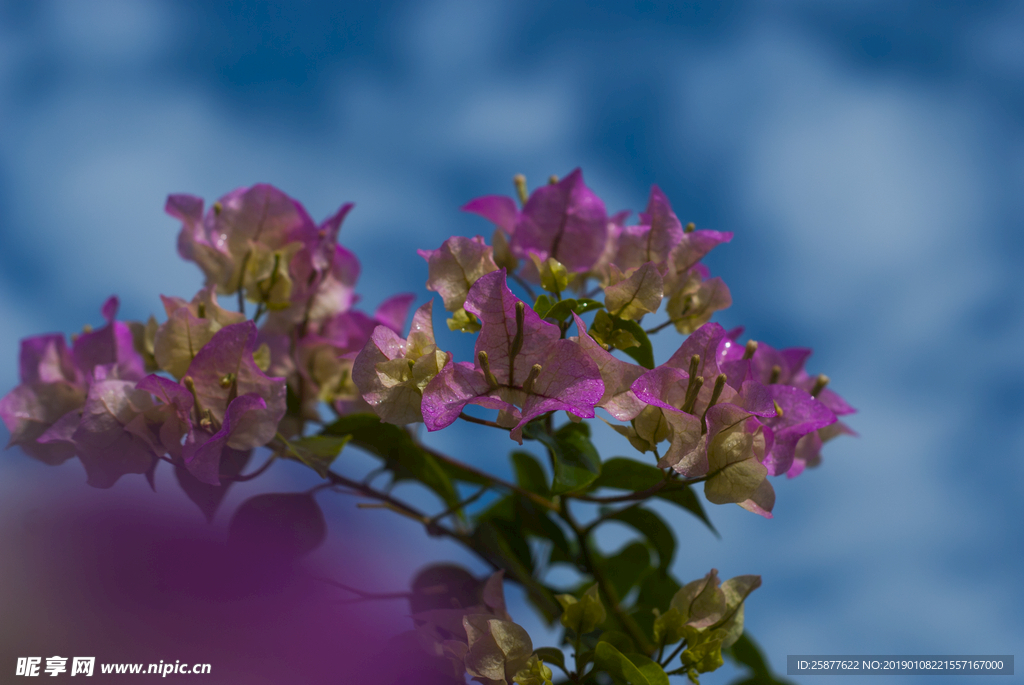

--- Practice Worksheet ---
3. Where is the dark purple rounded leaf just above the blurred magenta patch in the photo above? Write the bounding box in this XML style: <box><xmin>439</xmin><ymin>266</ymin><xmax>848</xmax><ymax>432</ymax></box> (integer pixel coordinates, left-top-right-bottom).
<box><xmin>227</xmin><ymin>493</ymin><xmax>327</xmax><ymax>558</ymax></box>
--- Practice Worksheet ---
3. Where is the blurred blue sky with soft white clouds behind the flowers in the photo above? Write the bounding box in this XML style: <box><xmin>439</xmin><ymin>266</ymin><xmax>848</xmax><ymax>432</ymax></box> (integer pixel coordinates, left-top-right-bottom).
<box><xmin>0</xmin><ymin>0</ymin><xmax>1024</xmax><ymax>683</ymax></box>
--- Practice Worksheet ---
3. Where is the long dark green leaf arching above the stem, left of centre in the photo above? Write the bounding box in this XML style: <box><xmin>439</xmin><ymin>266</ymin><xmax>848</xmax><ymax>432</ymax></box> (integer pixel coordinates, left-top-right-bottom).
<box><xmin>321</xmin><ymin>414</ymin><xmax>459</xmax><ymax>507</ymax></box>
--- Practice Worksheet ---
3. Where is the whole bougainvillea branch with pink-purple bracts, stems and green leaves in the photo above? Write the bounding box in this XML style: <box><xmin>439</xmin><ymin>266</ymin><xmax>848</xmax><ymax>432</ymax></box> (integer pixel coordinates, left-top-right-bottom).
<box><xmin>0</xmin><ymin>169</ymin><xmax>854</xmax><ymax>685</ymax></box>
